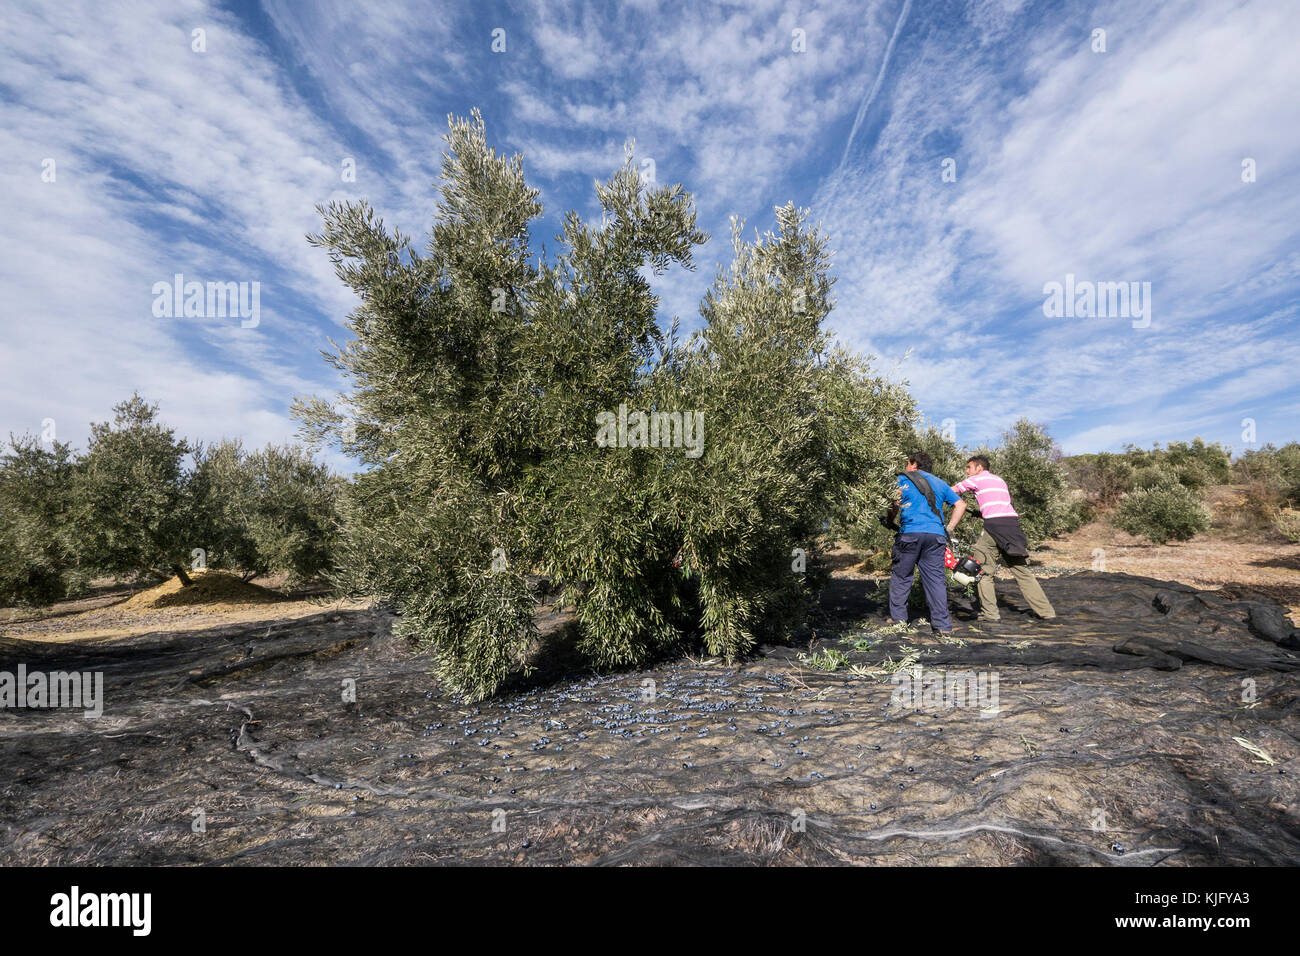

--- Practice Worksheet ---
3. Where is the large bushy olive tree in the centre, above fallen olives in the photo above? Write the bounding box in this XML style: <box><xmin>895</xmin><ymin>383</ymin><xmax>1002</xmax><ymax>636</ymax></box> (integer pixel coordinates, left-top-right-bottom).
<box><xmin>295</xmin><ymin>111</ymin><xmax>910</xmax><ymax>697</ymax></box>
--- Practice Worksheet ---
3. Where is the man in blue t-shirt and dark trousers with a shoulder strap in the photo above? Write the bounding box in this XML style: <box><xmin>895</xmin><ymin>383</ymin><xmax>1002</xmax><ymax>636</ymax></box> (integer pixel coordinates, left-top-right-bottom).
<box><xmin>889</xmin><ymin>451</ymin><xmax>966</xmax><ymax>633</ymax></box>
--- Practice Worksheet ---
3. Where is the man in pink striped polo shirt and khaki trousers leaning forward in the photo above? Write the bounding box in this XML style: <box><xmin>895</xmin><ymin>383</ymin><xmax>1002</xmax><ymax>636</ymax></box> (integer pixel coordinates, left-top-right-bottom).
<box><xmin>953</xmin><ymin>455</ymin><xmax>1056</xmax><ymax>623</ymax></box>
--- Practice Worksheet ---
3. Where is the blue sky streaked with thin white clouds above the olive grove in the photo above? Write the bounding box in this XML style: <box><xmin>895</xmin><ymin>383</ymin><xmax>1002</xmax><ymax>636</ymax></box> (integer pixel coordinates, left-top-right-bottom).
<box><xmin>0</xmin><ymin>0</ymin><xmax>1300</xmax><ymax>465</ymax></box>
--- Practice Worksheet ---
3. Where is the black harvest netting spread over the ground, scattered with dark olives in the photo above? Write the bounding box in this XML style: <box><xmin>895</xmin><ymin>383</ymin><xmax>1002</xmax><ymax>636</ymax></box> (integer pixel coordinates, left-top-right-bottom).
<box><xmin>0</xmin><ymin>574</ymin><xmax>1300</xmax><ymax>865</ymax></box>
